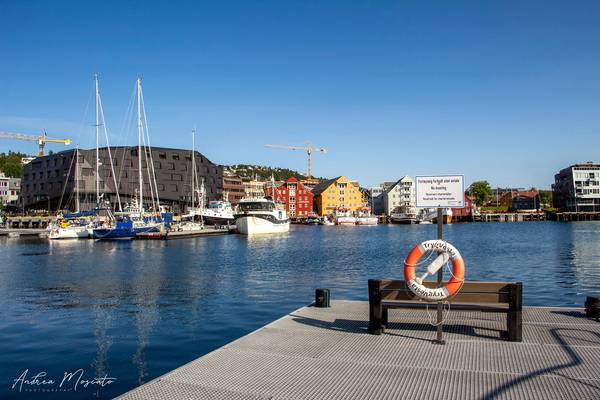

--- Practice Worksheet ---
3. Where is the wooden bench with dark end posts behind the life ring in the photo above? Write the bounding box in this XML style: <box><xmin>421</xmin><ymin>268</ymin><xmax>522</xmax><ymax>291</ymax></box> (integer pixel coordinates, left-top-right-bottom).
<box><xmin>369</xmin><ymin>279</ymin><xmax>523</xmax><ymax>342</ymax></box>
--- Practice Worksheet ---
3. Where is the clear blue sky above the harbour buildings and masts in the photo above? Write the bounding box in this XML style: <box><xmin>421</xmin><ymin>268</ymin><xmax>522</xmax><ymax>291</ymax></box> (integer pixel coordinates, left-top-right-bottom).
<box><xmin>0</xmin><ymin>0</ymin><xmax>600</xmax><ymax>188</ymax></box>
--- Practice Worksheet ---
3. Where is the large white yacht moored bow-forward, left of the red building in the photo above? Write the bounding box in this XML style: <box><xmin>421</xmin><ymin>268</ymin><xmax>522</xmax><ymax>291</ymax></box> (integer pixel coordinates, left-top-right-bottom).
<box><xmin>235</xmin><ymin>199</ymin><xmax>290</xmax><ymax>235</ymax></box>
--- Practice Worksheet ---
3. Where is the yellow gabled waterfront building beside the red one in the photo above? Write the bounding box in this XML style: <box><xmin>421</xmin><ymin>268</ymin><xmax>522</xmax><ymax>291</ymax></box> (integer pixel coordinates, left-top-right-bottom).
<box><xmin>312</xmin><ymin>176</ymin><xmax>365</xmax><ymax>216</ymax></box>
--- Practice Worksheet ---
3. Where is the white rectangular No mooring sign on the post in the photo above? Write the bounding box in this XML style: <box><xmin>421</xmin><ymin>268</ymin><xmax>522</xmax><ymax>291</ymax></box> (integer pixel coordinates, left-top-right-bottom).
<box><xmin>415</xmin><ymin>175</ymin><xmax>465</xmax><ymax>208</ymax></box>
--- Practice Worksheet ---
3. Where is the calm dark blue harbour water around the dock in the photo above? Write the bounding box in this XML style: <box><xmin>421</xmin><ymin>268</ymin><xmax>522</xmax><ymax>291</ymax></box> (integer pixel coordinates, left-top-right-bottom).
<box><xmin>0</xmin><ymin>222</ymin><xmax>600</xmax><ymax>400</ymax></box>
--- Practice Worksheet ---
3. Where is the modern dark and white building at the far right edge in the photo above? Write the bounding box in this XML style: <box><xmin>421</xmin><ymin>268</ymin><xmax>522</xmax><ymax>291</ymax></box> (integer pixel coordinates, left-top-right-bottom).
<box><xmin>552</xmin><ymin>162</ymin><xmax>600</xmax><ymax>212</ymax></box>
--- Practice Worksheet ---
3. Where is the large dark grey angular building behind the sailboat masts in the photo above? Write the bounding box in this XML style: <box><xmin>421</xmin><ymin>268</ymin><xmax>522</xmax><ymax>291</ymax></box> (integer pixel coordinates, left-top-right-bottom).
<box><xmin>21</xmin><ymin>147</ymin><xmax>223</xmax><ymax>212</ymax></box>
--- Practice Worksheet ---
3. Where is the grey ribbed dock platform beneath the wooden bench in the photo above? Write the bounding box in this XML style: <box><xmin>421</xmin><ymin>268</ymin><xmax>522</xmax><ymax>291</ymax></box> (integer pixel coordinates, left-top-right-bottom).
<box><xmin>119</xmin><ymin>301</ymin><xmax>600</xmax><ymax>400</ymax></box>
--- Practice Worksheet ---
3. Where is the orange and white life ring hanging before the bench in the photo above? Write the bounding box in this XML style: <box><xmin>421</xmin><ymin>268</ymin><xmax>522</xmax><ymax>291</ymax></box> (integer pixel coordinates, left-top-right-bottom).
<box><xmin>404</xmin><ymin>240</ymin><xmax>465</xmax><ymax>301</ymax></box>
